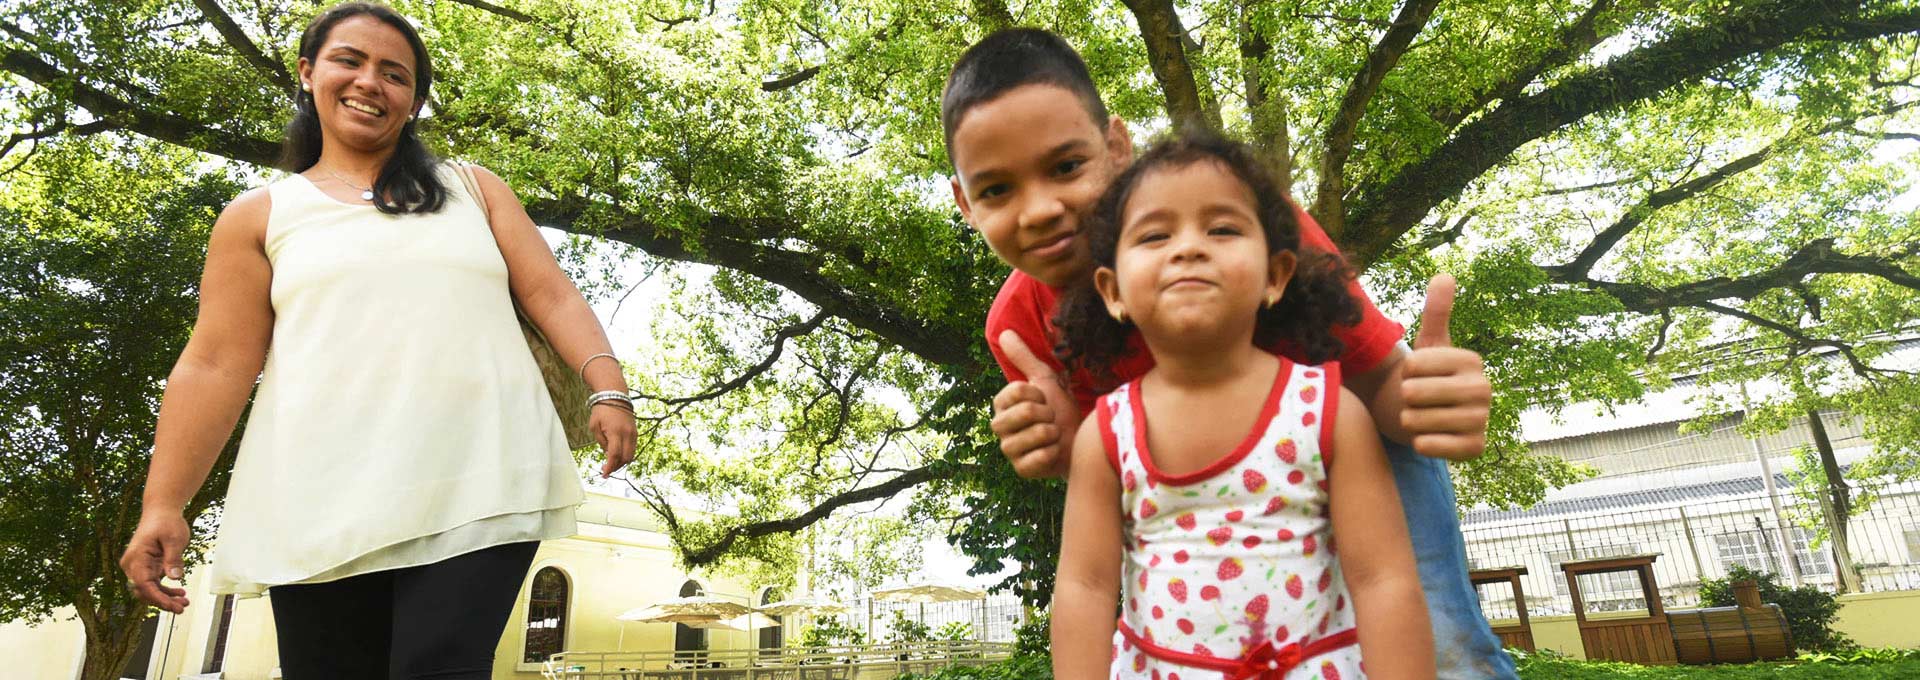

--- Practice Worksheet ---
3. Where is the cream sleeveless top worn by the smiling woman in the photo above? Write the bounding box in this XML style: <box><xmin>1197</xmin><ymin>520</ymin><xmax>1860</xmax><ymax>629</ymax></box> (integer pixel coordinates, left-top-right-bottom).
<box><xmin>211</xmin><ymin>165</ymin><xmax>584</xmax><ymax>595</ymax></box>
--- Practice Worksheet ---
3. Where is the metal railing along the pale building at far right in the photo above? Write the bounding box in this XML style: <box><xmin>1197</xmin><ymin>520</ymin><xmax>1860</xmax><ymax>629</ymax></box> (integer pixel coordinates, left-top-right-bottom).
<box><xmin>1461</xmin><ymin>482</ymin><xmax>1920</xmax><ymax>620</ymax></box>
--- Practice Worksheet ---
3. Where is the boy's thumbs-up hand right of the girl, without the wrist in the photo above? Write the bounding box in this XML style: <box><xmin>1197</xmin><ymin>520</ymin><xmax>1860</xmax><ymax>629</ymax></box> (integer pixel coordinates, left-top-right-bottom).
<box><xmin>1400</xmin><ymin>275</ymin><xmax>1494</xmax><ymax>461</ymax></box>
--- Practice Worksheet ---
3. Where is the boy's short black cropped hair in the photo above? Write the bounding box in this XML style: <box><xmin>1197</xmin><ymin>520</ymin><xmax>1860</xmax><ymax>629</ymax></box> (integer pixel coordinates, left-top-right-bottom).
<box><xmin>941</xmin><ymin>29</ymin><xmax>1106</xmax><ymax>159</ymax></box>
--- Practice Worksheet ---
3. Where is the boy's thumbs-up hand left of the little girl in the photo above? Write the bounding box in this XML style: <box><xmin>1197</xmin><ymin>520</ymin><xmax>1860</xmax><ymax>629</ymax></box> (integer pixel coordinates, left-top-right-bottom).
<box><xmin>993</xmin><ymin>330</ymin><xmax>1079</xmax><ymax>478</ymax></box>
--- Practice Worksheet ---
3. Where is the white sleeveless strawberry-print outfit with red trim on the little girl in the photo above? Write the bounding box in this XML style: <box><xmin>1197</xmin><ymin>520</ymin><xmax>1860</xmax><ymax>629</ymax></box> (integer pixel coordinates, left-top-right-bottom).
<box><xmin>1096</xmin><ymin>359</ymin><xmax>1365</xmax><ymax>680</ymax></box>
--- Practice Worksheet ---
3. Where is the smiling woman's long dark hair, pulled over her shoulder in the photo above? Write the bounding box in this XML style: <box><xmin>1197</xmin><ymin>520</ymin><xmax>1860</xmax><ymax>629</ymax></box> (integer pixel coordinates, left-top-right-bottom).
<box><xmin>280</xmin><ymin>2</ymin><xmax>447</xmax><ymax>215</ymax></box>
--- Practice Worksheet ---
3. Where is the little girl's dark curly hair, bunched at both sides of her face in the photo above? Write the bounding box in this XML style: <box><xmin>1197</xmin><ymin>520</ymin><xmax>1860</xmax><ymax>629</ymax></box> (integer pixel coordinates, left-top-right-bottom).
<box><xmin>1054</xmin><ymin>133</ymin><xmax>1359</xmax><ymax>382</ymax></box>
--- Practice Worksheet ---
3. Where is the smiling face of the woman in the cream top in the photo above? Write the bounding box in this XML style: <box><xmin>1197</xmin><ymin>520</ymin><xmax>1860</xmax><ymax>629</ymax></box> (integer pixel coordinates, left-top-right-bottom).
<box><xmin>300</xmin><ymin>15</ymin><xmax>420</xmax><ymax>152</ymax></box>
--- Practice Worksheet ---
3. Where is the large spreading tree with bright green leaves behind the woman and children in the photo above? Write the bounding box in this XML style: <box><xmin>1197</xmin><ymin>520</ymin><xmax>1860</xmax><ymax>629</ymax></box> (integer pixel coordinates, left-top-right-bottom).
<box><xmin>0</xmin><ymin>0</ymin><xmax>1920</xmax><ymax>597</ymax></box>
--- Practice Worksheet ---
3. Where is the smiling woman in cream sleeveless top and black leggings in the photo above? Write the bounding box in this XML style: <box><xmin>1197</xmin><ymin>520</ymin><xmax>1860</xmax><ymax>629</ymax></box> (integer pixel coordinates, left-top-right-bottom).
<box><xmin>121</xmin><ymin>2</ymin><xmax>636</xmax><ymax>680</ymax></box>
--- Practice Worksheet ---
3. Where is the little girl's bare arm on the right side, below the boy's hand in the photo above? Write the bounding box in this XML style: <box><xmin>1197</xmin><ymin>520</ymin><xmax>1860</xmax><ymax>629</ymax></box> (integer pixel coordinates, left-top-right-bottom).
<box><xmin>1328</xmin><ymin>390</ymin><xmax>1434</xmax><ymax>680</ymax></box>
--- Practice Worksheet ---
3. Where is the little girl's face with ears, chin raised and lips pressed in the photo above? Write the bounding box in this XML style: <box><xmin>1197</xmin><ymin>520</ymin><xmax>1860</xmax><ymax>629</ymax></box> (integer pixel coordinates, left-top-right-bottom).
<box><xmin>1094</xmin><ymin>161</ymin><xmax>1294</xmax><ymax>344</ymax></box>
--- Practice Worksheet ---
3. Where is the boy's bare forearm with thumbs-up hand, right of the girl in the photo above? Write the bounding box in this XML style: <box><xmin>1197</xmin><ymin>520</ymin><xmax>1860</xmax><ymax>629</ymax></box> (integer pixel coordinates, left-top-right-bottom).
<box><xmin>1344</xmin><ymin>275</ymin><xmax>1494</xmax><ymax>461</ymax></box>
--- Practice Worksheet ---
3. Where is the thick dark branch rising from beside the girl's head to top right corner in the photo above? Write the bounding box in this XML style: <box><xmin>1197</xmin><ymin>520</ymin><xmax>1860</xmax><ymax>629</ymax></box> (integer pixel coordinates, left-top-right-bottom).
<box><xmin>1340</xmin><ymin>0</ymin><xmax>1920</xmax><ymax>267</ymax></box>
